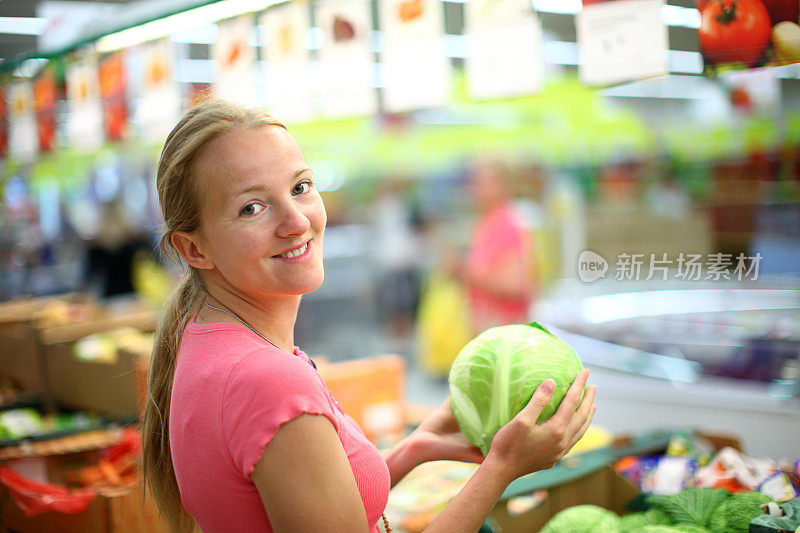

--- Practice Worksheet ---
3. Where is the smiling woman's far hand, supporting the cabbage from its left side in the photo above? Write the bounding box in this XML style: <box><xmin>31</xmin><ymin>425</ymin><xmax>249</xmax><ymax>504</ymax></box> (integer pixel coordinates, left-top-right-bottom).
<box><xmin>412</xmin><ymin>398</ymin><xmax>484</xmax><ymax>463</ymax></box>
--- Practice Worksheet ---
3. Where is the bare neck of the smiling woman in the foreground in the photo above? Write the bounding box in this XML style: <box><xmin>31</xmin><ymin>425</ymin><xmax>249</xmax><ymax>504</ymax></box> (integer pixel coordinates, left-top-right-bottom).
<box><xmin>195</xmin><ymin>284</ymin><xmax>300</xmax><ymax>353</ymax></box>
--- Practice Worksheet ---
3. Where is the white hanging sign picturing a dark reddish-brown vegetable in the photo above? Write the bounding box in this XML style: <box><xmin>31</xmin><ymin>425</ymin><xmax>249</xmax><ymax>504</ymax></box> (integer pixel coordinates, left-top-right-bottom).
<box><xmin>316</xmin><ymin>0</ymin><xmax>378</xmax><ymax>118</ymax></box>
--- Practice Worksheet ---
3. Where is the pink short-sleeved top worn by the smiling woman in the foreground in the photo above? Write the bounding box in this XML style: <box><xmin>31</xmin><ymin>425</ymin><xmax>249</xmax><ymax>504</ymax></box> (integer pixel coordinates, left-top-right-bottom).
<box><xmin>169</xmin><ymin>318</ymin><xmax>391</xmax><ymax>533</ymax></box>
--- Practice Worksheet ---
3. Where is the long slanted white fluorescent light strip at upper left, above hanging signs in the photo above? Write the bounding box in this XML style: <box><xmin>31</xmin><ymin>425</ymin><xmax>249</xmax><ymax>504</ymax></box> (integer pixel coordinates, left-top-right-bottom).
<box><xmin>97</xmin><ymin>0</ymin><xmax>283</xmax><ymax>53</ymax></box>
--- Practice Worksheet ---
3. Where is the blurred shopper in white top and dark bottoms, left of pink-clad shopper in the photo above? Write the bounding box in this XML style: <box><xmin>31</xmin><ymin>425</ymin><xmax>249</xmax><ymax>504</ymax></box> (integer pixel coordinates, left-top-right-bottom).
<box><xmin>370</xmin><ymin>178</ymin><xmax>420</xmax><ymax>338</ymax></box>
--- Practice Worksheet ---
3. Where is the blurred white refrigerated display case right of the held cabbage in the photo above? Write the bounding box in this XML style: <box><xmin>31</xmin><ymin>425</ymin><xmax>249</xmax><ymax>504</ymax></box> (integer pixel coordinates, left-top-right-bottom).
<box><xmin>535</xmin><ymin>279</ymin><xmax>800</xmax><ymax>458</ymax></box>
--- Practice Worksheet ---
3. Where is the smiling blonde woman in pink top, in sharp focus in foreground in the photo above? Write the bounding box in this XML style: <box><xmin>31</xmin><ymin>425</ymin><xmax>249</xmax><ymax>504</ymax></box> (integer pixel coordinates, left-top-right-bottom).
<box><xmin>143</xmin><ymin>102</ymin><xmax>594</xmax><ymax>533</ymax></box>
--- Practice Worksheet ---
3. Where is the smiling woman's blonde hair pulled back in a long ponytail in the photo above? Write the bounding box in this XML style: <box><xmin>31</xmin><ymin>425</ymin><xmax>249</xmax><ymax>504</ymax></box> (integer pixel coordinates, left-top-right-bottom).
<box><xmin>142</xmin><ymin>100</ymin><xmax>284</xmax><ymax>532</ymax></box>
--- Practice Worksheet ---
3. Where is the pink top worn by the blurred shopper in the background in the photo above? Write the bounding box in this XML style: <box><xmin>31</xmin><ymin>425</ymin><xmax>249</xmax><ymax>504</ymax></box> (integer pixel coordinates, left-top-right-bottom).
<box><xmin>466</xmin><ymin>205</ymin><xmax>531</xmax><ymax>329</ymax></box>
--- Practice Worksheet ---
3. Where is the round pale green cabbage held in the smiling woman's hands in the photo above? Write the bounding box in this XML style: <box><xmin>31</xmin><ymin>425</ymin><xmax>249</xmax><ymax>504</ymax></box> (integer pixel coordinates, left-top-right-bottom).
<box><xmin>449</xmin><ymin>322</ymin><xmax>583</xmax><ymax>455</ymax></box>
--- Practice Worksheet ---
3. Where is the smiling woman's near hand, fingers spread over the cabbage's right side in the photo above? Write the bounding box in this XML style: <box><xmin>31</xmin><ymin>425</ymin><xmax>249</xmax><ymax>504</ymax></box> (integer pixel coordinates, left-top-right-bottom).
<box><xmin>485</xmin><ymin>369</ymin><xmax>597</xmax><ymax>483</ymax></box>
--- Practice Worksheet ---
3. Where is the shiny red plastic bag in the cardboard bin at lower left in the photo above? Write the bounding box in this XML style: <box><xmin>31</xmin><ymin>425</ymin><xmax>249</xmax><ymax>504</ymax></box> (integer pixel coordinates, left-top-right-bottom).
<box><xmin>0</xmin><ymin>468</ymin><xmax>97</xmax><ymax>516</ymax></box>
